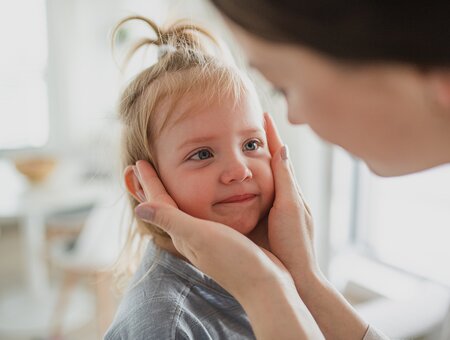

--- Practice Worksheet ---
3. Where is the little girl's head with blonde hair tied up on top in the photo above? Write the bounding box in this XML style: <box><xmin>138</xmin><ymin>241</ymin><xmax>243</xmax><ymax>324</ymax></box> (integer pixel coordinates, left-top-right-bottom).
<box><xmin>114</xmin><ymin>18</ymin><xmax>273</xmax><ymax>242</ymax></box>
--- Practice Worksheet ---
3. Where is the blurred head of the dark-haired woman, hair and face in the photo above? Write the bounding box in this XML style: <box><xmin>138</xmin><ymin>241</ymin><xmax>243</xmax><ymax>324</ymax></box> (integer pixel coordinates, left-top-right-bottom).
<box><xmin>213</xmin><ymin>0</ymin><xmax>450</xmax><ymax>176</ymax></box>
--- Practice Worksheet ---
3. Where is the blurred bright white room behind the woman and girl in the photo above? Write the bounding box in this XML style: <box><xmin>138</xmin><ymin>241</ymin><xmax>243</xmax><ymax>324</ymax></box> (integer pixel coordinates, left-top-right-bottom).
<box><xmin>0</xmin><ymin>0</ymin><xmax>450</xmax><ymax>339</ymax></box>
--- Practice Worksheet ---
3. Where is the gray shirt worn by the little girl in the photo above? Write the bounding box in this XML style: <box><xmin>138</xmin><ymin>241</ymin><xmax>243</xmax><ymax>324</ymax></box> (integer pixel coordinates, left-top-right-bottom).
<box><xmin>105</xmin><ymin>242</ymin><xmax>255</xmax><ymax>340</ymax></box>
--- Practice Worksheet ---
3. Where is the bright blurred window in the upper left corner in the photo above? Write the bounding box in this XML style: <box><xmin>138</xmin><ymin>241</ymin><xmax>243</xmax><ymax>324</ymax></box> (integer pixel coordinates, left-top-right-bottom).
<box><xmin>0</xmin><ymin>0</ymin><xmax>49</xmax><ymax>150</ymax></box>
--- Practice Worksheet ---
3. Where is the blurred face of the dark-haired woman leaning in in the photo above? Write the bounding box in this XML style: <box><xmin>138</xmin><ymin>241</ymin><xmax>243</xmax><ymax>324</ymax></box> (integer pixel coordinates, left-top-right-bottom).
<box><xmin>229</xmin><ymin>22</ymin><xmax>450</xmax><ymax>176</ymax></box>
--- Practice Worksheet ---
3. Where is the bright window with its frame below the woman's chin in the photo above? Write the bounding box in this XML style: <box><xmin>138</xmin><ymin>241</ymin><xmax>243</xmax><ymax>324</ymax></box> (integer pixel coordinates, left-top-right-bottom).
<box><xmin>331</xmin><ymin>150</ymin><xmax>450</xmax><ymax>285</ymax></box>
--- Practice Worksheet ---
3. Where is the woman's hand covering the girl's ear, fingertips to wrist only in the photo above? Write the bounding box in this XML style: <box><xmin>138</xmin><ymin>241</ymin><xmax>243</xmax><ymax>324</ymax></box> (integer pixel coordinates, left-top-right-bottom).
<box><xmin>132</xmin><ymin>161</ymin><xmax>292</xmax><ymax>295</ymax></box>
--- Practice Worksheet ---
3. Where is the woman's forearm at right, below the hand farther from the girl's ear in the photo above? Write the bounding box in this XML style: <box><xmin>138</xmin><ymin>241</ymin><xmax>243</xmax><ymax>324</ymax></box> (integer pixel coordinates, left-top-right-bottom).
<box><xmin>294</xmin><ymin>273</ymin><xmax>368</xmax><ymax>340</ymax></box>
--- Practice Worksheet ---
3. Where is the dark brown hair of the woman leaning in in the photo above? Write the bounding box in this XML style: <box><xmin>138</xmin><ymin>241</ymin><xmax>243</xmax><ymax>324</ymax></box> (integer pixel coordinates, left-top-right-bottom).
<box><xmin>212</xmin><ymin>0</ymin><xmax>450</xmax><ymax>66</ymax></box>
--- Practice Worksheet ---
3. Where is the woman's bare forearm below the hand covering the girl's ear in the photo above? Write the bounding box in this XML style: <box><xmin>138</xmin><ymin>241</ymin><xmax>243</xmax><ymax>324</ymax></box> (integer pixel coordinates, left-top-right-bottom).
<box><xmin>237</xmin><ymin>281</ymin><xmax>323</xmax><ymax>340</ymax></box>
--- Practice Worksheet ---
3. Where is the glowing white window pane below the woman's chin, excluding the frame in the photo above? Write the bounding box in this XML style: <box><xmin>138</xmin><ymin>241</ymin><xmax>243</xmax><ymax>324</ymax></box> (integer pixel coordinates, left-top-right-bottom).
<box><xmin>356</xmin><ymin>165</ymin><xmax>450</xmax><ymax>286</ymax></box>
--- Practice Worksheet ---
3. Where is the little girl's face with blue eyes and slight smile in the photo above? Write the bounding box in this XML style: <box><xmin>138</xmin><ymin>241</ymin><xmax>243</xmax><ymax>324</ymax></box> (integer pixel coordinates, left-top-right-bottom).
<box><xmin>155</xmin><ymin>95</ymin><xmax>274</xmax><ymax>234</ymax></box>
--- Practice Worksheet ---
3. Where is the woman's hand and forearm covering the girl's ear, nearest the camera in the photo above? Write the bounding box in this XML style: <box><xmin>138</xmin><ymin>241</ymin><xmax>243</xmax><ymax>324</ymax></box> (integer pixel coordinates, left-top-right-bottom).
<box><xmin>132</xmin><ymin>161</ymin><xmax>323</xmax><ymax>340</ymax></box>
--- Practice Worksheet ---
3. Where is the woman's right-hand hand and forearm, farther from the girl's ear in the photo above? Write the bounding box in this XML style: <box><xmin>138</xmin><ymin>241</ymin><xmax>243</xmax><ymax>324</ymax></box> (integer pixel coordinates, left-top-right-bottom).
<box><xmin>265</xmin><ymin>114</ymin><xmax>368</xmax><ymax>340</ymax></box>
